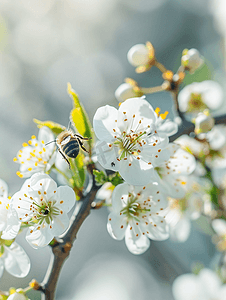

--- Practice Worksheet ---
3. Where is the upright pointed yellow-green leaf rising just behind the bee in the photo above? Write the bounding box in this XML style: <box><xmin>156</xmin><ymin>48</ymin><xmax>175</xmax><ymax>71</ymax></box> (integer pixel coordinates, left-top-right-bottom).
<box><xmin>67</xmin><ymin>83</ymin><xmax>93</xmax><ymax>150</ymax></box>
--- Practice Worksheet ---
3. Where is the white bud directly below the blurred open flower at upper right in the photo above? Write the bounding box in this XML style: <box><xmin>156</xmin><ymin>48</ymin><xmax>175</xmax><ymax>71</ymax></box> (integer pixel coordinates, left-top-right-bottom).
<box><xmin>195</xmin><ymin>109</ymin><xmax>214</xmax><ymax>134</ymax></box>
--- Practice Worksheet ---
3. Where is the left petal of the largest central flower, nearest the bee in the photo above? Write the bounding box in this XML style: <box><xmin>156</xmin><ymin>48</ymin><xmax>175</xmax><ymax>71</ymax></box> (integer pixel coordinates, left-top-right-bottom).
<box><xmin>93</xmin><ymin>105</ymin><xmax>118</xmax><ymax>142</ymax></box>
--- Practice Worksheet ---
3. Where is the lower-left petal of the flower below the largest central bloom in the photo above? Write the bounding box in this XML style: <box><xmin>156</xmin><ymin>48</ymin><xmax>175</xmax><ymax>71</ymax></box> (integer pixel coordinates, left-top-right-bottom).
<box><xmin>107</xmin><ymin>212</ymin><xmax>127</xmax><ymax>240</ymax></box>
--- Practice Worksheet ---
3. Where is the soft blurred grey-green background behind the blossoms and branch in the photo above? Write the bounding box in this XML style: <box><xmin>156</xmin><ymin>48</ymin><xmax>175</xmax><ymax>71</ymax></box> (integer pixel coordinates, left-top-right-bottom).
<box><xmin>0</xmin><ymin>0</ymin><xmax>226</xmax><ymax>300</ymax></box>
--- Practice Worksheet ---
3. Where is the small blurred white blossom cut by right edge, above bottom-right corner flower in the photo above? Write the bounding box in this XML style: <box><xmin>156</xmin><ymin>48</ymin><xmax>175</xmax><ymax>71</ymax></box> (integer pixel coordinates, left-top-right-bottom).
<box><xmin>212</xmin><ymin>219</ymin><xmax>226</xmax><ymax>251</ymax></box>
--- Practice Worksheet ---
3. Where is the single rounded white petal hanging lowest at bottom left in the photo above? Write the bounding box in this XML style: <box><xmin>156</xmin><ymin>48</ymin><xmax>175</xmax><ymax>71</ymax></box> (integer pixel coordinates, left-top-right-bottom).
<box><xmin>4</xmin><ymin>242</ymin><xmax>31</xmax><ymax>277</ymax></box>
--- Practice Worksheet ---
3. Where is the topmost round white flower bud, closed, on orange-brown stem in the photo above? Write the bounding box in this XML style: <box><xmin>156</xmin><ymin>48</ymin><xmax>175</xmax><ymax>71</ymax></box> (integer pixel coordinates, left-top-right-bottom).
<box><xmin>127</xmin><ymin>44</ymin><xmax>150</xmax><ymax>67</ymax></box>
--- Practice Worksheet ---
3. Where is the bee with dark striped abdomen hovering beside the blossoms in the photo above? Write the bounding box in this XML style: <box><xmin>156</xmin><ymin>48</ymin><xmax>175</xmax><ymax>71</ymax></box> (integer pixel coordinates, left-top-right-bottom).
<box><xmin>46</xmin><ymin>122</ymin><xmax>91</xmax><ymax>169</ymax></box>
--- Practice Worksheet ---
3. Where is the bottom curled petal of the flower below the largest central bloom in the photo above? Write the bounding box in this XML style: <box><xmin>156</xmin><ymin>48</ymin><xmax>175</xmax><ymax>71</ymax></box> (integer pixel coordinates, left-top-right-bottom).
<box><xmin>125</xmin><ymin>227</ymin><xmax>151</xmax><ymax>254</ymax></box>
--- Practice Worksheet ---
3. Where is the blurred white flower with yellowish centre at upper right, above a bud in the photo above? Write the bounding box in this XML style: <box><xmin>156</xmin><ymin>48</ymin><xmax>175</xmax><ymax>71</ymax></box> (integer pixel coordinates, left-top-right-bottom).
<box><xmin>178</xmin><ymin>80</ymin><xmax>223</xmax><ymax>113</ymax></box>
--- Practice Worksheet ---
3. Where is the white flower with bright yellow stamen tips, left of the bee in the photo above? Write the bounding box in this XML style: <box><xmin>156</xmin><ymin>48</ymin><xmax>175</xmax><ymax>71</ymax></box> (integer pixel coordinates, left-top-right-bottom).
<box><xmin>14</xmin><ymin>127</ymin><xmax>55</xmax><ymax>177</ymax></box>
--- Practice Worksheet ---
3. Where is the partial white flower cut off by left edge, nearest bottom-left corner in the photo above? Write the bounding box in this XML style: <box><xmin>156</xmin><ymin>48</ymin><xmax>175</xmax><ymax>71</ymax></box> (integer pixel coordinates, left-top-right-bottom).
<box><xmin>0</xmin><ymin>238</ymin><xmax>31</xmax><ymax>277</ymax></box>
